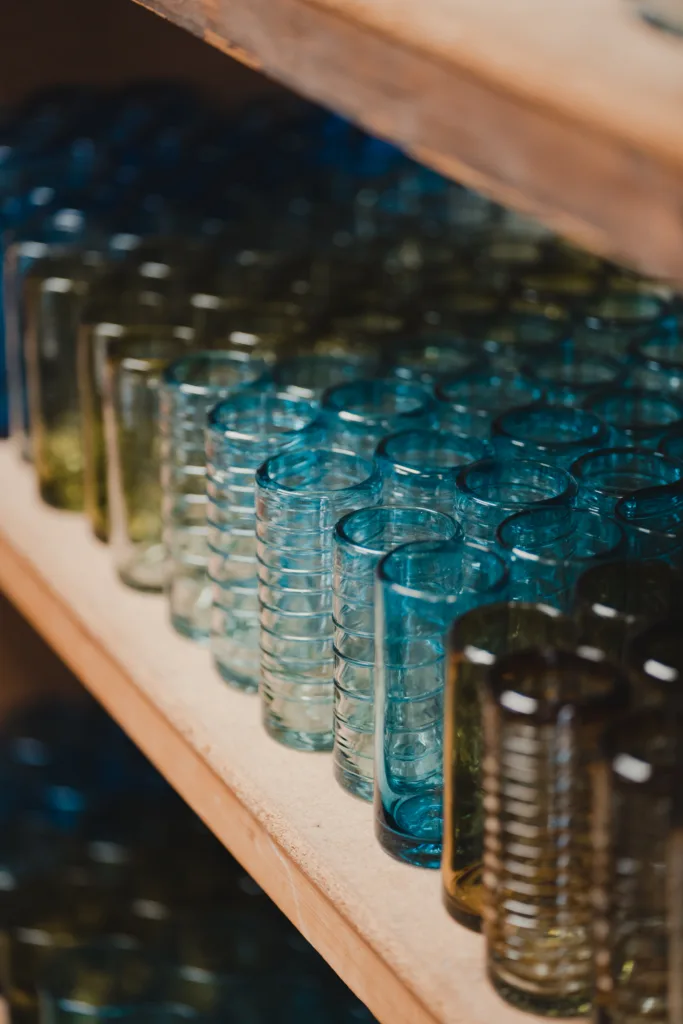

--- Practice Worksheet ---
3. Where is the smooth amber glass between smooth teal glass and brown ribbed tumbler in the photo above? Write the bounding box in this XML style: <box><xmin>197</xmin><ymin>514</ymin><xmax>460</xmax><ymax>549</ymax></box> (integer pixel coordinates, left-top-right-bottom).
<box><xmin>441</xmin><ymin>600</ymin><xmax>577</xmax><ymax>932</ymax></box>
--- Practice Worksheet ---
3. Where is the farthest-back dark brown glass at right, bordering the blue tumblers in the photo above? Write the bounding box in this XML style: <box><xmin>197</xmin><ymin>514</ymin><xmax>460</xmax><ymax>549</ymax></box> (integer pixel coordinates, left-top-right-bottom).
<box><xmin>574</xmin><ymin>559</ymin><xmax>683</xmax><ymax>664</ymax></box>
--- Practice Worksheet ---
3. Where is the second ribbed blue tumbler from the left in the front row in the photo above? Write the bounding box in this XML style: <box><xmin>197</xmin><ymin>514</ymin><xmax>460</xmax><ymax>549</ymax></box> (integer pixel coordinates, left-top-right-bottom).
<box><xmin>206</xmin><ymin>388</ymin><xmax>322</xmax><ymax>691</ymax></box>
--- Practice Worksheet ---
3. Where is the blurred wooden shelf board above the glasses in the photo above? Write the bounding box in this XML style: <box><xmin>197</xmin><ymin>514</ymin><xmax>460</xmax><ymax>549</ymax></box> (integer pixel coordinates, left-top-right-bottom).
<box><xmin>132</xmin><ymin>0</ymin><xmax>683</xmax><ymax>283</ymax></box>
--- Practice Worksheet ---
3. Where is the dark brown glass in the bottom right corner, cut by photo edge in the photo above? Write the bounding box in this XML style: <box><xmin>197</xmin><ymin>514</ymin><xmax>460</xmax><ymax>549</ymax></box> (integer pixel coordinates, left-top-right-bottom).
<box><xmin>592</xmin><ymin>708</ymin><xmax>683</xmax><ymax>1024</ymax></box>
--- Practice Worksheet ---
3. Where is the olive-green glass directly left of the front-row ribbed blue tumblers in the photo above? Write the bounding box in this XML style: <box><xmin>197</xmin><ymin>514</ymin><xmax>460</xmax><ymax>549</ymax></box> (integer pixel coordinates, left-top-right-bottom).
<box><xmin>103</xmin><ymin>330</ymin><xmax>185</xmax><ymax>591</ymax></box>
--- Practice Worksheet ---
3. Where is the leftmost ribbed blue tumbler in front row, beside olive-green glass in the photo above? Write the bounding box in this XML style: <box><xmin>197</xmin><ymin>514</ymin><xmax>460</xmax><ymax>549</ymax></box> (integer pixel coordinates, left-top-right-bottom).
<box><xmin>161</xmin><ymin>351</ymin><xmax>269</xmax><ymax>640</ymax></box>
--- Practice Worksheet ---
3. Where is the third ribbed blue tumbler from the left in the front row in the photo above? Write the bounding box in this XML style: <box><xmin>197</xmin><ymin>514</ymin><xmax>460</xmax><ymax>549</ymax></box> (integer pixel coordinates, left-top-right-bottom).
<box><xmin>256</xmin><ymin>449</ymin><xmax>381</xmax><ymax>751</ymax></box>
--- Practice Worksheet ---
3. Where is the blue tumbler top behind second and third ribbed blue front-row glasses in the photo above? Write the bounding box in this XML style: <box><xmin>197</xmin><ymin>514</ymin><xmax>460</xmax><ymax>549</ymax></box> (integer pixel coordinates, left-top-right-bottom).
<box><xmin>322</xmin><ymin>379</ymin><xmax>434</xmax><ymax>457</ymax></box>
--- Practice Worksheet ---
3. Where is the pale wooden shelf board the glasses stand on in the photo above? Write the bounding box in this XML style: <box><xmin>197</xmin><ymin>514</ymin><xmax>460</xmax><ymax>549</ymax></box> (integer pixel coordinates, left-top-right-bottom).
<box><xmin>0</xmin><ymin>442</ymin><xmax>573</xmax><ymax>1024</ymax></box>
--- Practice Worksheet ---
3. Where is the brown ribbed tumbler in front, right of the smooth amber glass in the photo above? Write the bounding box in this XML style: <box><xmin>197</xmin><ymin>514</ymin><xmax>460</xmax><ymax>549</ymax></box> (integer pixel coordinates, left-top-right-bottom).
<box><xmin>483</xmin><ymin>650</ymin><xmax>629</xmax><ymax>1017</ymax></box>
